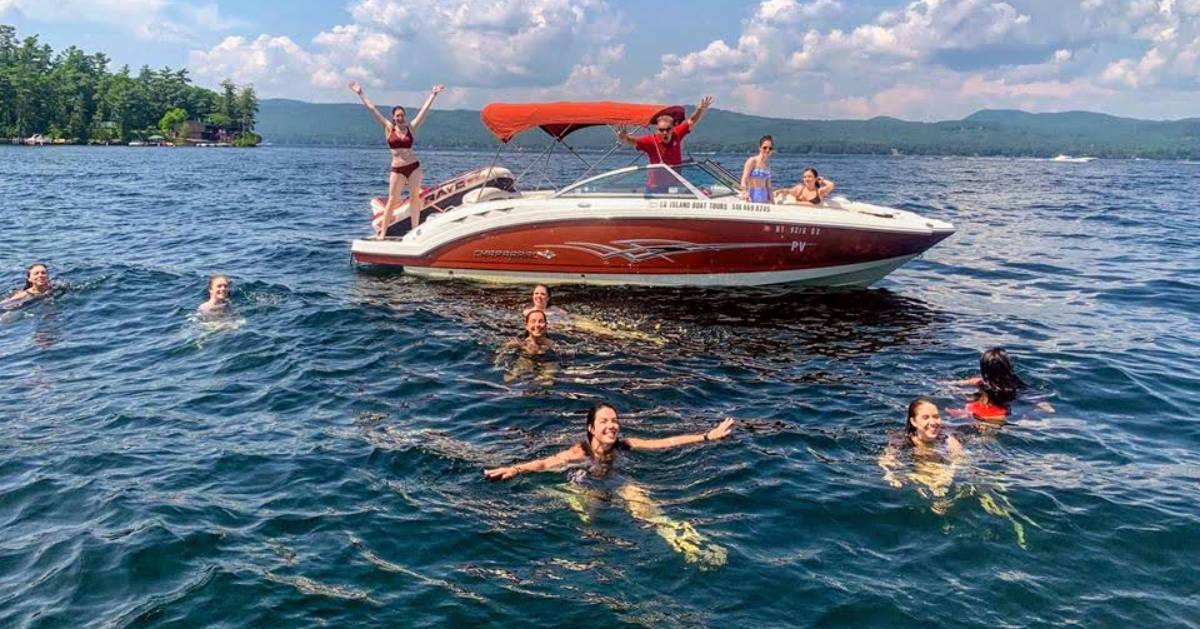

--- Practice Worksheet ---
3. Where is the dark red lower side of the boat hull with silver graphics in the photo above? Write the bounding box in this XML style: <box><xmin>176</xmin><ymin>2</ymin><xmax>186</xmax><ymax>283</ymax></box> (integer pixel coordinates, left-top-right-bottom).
<box><xmin>354</xmin><ymin>218</ymin><xmax>949</xmax><ymax>275</ymax></box>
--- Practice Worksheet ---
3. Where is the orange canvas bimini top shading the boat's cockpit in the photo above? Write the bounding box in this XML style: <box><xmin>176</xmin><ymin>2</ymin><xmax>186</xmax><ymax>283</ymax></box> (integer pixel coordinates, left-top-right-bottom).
<box><xmin>479</xmin><ymin>101</ymin><xmax>684</xmax><ymax>143</ymax></box>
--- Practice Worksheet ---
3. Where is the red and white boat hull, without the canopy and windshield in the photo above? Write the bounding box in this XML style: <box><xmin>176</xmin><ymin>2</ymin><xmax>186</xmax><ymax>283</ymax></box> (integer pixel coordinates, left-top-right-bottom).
<box><xmin>353</xmin><ymin>198</ymin><xmax>954</xmax><ymax>286</ymax></box>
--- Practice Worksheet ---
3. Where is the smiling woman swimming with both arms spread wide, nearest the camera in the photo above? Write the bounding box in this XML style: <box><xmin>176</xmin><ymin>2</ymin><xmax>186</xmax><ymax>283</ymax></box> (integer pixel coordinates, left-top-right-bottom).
<box><xmin>484</xmin><ymin>402</ymin><xmax>733</xmax><ymax>568</ymax></box>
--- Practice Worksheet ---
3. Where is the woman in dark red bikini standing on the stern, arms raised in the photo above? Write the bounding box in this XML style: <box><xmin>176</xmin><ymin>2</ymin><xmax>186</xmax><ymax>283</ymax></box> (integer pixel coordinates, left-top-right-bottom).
<box><xmin>350</xmin><ymin>80</ymin><xmax>445</xmax><ymax>239</ymax></box>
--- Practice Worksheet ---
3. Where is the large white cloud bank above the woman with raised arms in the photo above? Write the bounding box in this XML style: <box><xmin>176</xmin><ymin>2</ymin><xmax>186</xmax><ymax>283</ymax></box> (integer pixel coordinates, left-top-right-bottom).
<box><xmin>190</xmin><ymin>0</ymin><xmax>624</xmax><ymax>96</ymax></box>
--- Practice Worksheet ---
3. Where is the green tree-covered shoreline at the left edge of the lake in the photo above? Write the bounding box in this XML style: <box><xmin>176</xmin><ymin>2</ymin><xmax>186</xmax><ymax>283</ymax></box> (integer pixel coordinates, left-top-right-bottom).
<box><xmin>0</xmin><ymin>24</ymin><xmax>260</xmax><ymax>145</ymax></box>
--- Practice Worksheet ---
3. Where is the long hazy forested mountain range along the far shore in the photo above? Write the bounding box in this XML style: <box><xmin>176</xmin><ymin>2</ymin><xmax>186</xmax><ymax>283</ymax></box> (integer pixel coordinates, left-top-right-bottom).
<box><xmin>256</xmin><ymin>98</ymin><xmax>1200</xmax><ymax>160</ymax></box>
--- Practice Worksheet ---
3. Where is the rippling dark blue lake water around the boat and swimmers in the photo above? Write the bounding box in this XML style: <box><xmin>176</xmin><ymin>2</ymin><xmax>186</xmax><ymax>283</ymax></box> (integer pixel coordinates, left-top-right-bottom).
<box><xmin>0</xmin><ymin>146</ymin><xmax>1200</xmax><ymax>627</ymax></box>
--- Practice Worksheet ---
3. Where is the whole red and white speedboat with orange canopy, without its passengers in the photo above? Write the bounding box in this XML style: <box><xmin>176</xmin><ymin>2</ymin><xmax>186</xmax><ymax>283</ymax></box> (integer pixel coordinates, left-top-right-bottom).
<box><xmin>352</xmin><ymin>102</ymin><xmax>954</xmax><ymax>286</ymax></box>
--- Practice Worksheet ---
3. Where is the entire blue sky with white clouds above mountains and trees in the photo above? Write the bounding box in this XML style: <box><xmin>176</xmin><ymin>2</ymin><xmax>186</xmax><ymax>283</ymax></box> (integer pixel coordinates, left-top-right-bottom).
<box><xmin>0</xmin><ymin>0</ymin><xmax>1200</xmax><ymax>120</ymax></box>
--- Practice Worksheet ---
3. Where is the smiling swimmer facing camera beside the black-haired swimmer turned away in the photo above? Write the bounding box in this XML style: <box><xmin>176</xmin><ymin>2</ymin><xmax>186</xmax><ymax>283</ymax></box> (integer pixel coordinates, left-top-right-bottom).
<box><xmin>878</xmin><ymin>397</ymin><xmax>966</xmax><ymax>513</ymax></box>
